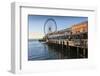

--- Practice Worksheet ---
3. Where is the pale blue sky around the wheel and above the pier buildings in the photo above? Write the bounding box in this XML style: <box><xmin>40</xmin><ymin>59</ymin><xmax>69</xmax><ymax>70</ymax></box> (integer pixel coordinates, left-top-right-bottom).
<box><xmin>28</xmin><ymin>15</ymin><xmax>88</xmax><ymax>39</ymax></box>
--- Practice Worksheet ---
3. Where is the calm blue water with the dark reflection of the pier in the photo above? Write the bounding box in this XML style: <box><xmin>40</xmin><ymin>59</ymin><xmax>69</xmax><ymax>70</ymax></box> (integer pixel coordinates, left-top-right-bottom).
<box><xmin>28</xmin><ymin>40</ymin><xmax>87</xmax><ymax>60</ymax></box>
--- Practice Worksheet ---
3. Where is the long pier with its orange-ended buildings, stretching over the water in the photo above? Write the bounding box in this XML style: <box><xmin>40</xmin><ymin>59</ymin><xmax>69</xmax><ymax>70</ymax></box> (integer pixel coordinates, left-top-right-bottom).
<box><xmin>44</xmin><ymin>21</ymin><xmax>88</xmax><ymax>58</ymax></box>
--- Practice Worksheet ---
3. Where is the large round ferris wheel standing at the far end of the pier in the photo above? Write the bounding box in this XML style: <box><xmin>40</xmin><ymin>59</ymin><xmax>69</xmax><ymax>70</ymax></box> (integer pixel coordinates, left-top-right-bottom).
<box><xmin>44</xmin><ymin>18</ymin><xmax>57</xmax><ymax>35</ymax></box>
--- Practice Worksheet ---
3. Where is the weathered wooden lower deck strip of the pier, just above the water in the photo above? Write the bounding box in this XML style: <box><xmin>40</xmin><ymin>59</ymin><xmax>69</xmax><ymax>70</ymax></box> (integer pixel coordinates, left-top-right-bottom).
<box><xmin>46</xmin><ymin>39</ymin><xmax>88</xmax><ymax>48</ymax></box>
